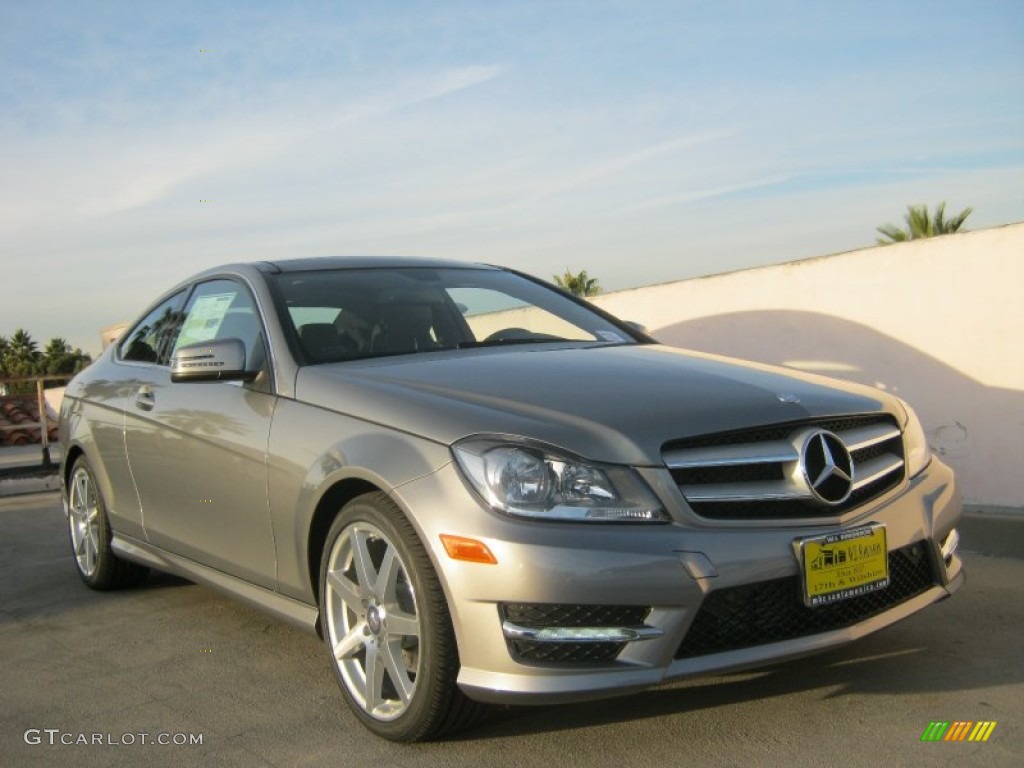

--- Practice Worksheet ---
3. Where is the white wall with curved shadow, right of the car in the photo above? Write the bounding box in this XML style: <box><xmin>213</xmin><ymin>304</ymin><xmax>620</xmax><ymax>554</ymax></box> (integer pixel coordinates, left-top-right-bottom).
<box><xmin>593</xmin><ymin>223</ymin><xmax>1024</xmax><ymax>510</ymax></box>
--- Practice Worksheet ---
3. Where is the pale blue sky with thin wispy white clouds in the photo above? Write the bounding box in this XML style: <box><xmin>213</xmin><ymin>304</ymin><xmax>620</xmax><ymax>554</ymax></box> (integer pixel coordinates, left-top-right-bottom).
<box><xmin>0</xmin><ymin>0</ymin><xmax>1024</xmax><ymax>351</ymax></box>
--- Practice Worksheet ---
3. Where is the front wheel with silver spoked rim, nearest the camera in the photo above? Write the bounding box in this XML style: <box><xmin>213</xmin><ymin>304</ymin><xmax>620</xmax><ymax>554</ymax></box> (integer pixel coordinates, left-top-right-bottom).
<box><xmin>319</xmin><ymin>493</ymin><xmax>484</xmax><ymax>741</ymax></box>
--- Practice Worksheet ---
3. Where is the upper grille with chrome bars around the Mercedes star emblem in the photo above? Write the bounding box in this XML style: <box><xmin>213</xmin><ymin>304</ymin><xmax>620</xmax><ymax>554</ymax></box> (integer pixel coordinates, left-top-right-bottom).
<box><xmin>662</xmin><ymin>415</ymin><xmax>905</xmax><ymax>520</ymax></box>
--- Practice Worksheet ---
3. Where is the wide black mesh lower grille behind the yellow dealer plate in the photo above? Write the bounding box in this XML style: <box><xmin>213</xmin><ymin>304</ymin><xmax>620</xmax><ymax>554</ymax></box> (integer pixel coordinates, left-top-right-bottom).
<box><xmin>676</xmin><ymin>542</ymin><xmax>937</xmax><ymax>658</ymax></box>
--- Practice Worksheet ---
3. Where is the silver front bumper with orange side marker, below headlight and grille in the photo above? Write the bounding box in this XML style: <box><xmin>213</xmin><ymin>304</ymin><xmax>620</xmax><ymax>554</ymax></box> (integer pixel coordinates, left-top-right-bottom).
<box><xmin>393</xmin><ymin>459</ymin><xmax>964</xmax><ymax>703</ymax></box>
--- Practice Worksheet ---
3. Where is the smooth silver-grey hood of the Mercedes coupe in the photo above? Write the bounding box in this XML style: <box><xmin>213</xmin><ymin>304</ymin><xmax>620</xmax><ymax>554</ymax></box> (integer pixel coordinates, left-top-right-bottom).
<box><xmin>296</xmin><ymin>344</ymin><xmax>900</xmax><ymax>466</ymax></box>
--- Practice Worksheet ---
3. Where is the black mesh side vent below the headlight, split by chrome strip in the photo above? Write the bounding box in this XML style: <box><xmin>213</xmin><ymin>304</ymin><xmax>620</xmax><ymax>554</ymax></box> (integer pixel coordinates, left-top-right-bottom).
<box><xmin>501</xmin><ymin>603</ymin><xmax>650</xmax><ymax>664</ymax></box>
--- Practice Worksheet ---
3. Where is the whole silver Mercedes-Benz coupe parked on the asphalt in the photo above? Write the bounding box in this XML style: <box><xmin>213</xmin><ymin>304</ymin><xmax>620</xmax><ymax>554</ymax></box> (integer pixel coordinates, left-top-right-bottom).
<box><xmin>60</xmin><ymin>258</ymin><xmax>964</xmax><ymax>740</ymax></box>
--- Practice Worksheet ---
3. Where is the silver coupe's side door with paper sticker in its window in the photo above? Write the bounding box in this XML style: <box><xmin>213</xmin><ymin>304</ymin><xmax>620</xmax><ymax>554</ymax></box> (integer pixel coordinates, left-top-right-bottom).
<box><xmin>125</xmin><ymin>280</ymin><xmax>276</xmax><ymax>588</ymax></box>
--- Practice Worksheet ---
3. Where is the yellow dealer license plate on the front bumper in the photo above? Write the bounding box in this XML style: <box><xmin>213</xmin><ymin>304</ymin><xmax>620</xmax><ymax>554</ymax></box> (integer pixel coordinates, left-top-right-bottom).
<box><xmin>799</xmin><ymin>524</ymin><xmax>889</xmax><ymax>607</ymax></box>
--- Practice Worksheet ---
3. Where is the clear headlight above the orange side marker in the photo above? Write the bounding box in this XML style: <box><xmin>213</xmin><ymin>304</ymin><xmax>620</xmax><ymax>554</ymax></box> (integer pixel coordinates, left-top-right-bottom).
<box><xmin>453</xmin><ymin>437</ymin><xmax>670</xmax><ymax>522</ymax></box>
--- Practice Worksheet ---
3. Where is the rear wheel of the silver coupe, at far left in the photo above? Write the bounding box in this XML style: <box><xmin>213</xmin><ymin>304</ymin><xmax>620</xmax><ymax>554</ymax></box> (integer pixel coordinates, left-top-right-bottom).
<box><xmin>68</xmin><ymin>457</ymin><xmax>150</xmax><ymax>591</ymax></box>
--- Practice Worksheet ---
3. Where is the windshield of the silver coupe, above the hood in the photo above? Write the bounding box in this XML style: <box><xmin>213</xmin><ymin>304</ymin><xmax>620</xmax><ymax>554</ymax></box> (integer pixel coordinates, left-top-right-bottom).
<box><xmin>273</xmin><ymin>267</ymin><xmax>635</xmax><ymax>364</ymax></box>
